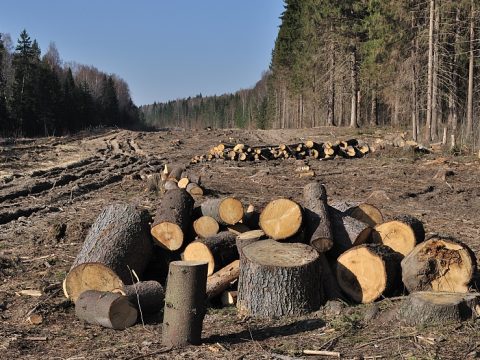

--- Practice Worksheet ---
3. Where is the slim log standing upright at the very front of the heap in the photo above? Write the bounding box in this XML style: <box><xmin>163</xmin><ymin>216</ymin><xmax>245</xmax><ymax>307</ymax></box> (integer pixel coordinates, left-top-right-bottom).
<box><xmin>162</xmin><ymin>261</ymin><xmax>207</xmax><ymax>347</ymax></box>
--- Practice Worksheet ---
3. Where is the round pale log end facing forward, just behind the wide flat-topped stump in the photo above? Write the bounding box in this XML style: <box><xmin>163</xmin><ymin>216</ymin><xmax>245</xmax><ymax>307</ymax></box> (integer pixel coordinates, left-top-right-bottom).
<box><xmin>259</xmin><ymin>199</ymin><xmax>303</xmax><ymax>240</ymax></box>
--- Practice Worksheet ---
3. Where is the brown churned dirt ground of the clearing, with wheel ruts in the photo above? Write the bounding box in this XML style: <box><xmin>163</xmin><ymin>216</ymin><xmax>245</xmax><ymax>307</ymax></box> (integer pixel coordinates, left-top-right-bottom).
<box><xmin>0</xmin><ymin>128</ymin><xmax>480</xmax><ymax>360</ymax></box>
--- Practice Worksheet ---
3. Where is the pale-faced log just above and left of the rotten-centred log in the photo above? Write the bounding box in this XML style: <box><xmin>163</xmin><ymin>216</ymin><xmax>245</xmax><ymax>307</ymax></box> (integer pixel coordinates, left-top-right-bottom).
<box><xmin>372</xmin><ymin>215</ymin><xmax>425</xmax><ymax>256</ymax></box>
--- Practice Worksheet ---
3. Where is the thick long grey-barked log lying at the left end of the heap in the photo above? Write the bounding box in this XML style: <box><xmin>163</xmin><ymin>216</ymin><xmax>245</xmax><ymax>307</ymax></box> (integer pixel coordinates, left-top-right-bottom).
<box><xmin>65</xmin><ymin>203</ymin><xmax>153</xmax><ymax>301</ymax></box>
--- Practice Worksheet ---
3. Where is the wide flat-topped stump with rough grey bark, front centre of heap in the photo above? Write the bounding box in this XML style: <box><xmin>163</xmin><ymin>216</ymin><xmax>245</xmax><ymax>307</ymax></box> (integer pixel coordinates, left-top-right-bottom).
<box><xmin>237</xmin><ymin>239</ymin><xmax>322</xmax><ymax>317</ymax></box>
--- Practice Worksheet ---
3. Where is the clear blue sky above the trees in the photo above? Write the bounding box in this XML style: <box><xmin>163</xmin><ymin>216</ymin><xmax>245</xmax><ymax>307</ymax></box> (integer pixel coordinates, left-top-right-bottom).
<box><xmin>0</xmin><ymin>0</ymin><xmax>283</xmax><ymax>105</ymax></box>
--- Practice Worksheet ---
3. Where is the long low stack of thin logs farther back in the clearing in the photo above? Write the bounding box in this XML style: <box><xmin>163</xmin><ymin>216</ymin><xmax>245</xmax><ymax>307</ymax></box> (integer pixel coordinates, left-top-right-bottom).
<box><xmin>191</xmin><ymin>139</ymin><xmax>372</xmax><ymax>164</ymax></box>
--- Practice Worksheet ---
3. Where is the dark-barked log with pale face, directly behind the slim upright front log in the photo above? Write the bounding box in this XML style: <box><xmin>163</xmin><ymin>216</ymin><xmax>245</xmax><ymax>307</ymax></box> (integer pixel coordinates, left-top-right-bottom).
<box><xmin>183</xmin><ymin>231</ymin><xmax>238</xmax><ymax>276</ymax></box>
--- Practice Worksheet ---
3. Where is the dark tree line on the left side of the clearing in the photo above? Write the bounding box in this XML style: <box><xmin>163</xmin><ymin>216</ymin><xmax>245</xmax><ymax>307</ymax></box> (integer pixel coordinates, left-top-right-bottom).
<box><xmin>0</xmin><ymin>30</ymin><xmax>140</xmax><ymax>136</ymax></box>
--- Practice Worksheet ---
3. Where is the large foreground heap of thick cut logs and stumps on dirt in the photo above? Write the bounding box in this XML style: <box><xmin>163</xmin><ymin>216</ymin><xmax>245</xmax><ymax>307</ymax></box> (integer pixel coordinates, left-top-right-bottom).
<box><xmin>64</xmin><ymin>165</ymin><xmax>480</xmax><ymax>336</ymax></box>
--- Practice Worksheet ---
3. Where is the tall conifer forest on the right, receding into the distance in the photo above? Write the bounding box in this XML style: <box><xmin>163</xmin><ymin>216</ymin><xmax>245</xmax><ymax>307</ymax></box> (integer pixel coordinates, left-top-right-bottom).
<box><xmin>142</xmin><ymin>0</ymin><xmax>480</xmax><ymax>147</ymax></box>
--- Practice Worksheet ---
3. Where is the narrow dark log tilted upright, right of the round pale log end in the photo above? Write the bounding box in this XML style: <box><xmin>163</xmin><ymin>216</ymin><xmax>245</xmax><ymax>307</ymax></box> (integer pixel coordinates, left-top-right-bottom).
<box><xmin>303</xmin><ymin>182</ymin><xmax>333</xmax><ymax>253</ymax></box>
